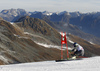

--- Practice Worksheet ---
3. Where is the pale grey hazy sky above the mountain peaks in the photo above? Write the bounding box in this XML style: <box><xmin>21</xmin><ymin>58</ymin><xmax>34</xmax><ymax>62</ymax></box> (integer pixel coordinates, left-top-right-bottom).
<box><xmin>0</xmin><ymin>0</ymin><xmax>100</xmax><ymax>12</ymax></box>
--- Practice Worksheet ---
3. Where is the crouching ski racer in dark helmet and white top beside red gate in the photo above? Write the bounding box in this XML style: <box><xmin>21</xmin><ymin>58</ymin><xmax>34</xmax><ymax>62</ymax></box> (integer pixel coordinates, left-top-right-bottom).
<box><xmin>71</xmin><ymin>42</ymin><xmax>84</xmax><ymax>56</ymax></box>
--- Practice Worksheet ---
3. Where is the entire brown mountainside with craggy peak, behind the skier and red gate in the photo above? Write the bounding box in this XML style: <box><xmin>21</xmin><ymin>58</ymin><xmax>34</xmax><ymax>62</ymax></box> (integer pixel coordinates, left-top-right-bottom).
<box><xmin>0</xmin><ymin>16</ymin><xmax>100</xmax><ymax>64</ymax></box>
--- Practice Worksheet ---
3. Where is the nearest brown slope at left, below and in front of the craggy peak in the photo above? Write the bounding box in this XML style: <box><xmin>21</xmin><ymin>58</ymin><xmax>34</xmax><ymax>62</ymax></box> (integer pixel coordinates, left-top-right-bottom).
<box><xmin>0</xmin><ymin>19</ymin><xmax>60</xmax><ymax>64</ymax></box>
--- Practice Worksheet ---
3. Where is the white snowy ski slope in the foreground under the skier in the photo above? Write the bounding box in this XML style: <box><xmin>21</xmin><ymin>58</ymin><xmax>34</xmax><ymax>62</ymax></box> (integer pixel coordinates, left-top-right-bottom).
<box><xmin>0</xmin><ymin>56</ymin><xmax>100</xmax><ymax>71</ymax></box>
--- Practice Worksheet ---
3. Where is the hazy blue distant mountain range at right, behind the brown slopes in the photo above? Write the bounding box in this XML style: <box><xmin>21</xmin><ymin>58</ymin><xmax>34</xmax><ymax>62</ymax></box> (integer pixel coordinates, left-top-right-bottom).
<box><xmin>0</xmin><ymin>9</ymin><xmax>100</xmax><ymax>44</ymax></box>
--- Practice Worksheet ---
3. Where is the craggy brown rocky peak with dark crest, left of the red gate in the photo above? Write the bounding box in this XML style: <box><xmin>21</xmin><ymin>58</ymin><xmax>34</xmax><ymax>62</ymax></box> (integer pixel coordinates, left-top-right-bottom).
<box><xmin>16</xmin><ymin>16</ymin><xmax>60</xmax><ymax>44</ymax></box>
